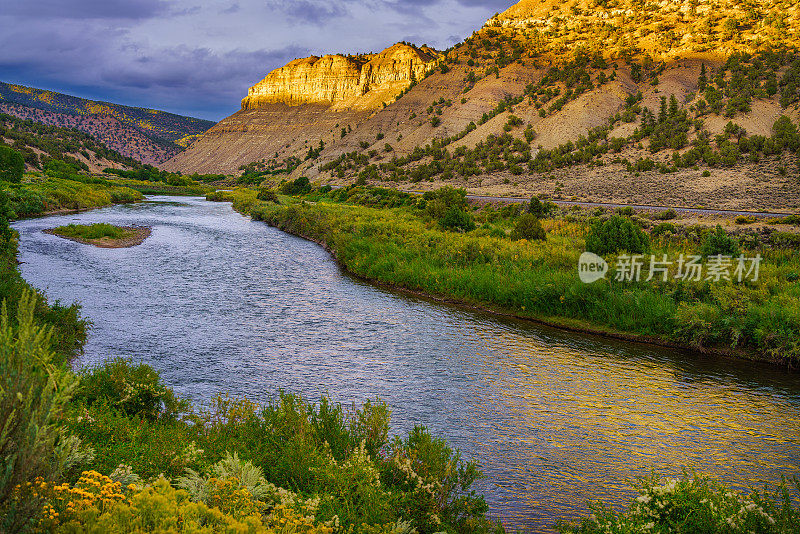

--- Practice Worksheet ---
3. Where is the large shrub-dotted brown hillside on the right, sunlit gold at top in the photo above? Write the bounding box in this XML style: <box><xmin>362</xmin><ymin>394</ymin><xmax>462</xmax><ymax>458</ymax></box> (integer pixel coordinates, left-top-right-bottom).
<box><xmin>167</xmin><ymin>0</ymin><xmax>800</xmax><ymax>209</ymax></box>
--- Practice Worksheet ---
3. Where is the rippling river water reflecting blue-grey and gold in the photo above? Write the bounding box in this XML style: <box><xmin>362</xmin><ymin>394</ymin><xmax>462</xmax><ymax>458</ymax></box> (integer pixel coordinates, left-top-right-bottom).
<box><xmin>14</xmin><ymin>197</ymin><xmax>800</xmax><ymax>532</ymax></box>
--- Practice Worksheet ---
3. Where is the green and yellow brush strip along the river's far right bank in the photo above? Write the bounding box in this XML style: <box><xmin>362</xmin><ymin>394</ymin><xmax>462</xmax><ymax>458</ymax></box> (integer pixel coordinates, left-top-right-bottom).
<box><xmin>209</xmin><ymin>188</ymin><xmax>800</xmax><ymax>367</ymax></box>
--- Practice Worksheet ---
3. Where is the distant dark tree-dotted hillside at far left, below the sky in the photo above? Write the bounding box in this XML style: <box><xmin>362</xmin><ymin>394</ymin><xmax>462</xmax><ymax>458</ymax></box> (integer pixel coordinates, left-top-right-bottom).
<box><xmin>0</xmin><ymin>82</ymin><xmax>214</xmax><ymax>164</ymax></box>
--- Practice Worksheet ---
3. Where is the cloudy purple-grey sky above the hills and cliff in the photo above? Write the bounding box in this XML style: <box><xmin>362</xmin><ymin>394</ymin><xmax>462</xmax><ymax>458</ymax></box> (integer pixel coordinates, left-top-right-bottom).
<box><xmin>0</xmin><ymin>0</ymin><xmax>514</xmax><ymax>120</ymax></box>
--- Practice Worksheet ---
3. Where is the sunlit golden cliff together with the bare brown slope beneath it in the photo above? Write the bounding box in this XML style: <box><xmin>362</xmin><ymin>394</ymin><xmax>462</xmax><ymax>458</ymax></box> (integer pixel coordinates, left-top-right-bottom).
<box><xmin>162</xmin><ymin>43</ymin><xmax>438</xmax><ymax>173</ymax></box>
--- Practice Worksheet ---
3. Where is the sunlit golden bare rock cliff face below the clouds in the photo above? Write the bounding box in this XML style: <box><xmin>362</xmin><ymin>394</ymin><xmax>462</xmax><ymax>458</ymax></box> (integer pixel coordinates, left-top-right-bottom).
<box><xmin>242</xmin><ymin>43</ymin><xmax>437</xmax><ymax>110</ymax></box>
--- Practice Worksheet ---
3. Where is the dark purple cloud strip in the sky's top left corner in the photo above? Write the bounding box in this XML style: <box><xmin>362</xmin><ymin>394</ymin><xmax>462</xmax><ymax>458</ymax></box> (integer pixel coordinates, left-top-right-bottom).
<box><xmin>3</xmin><ymin>0</ymin><xmax>168</xmax><ymax>19</ymax></box>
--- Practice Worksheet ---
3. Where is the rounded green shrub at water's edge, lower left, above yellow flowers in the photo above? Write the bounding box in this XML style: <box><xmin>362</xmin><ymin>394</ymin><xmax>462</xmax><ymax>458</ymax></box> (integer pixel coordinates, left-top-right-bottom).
<box><xmin>75</xmin><ymin>358</ymin><xmax>189</xmax><ymax>421</ymax></box>
